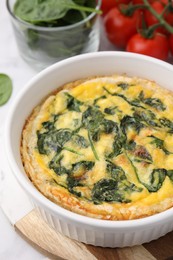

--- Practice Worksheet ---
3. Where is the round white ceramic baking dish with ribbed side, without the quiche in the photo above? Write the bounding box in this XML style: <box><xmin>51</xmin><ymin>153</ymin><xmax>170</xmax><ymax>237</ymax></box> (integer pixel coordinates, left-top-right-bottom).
<box><xmin>5</xmin><ymin>52</ymin><xmax>173</xmax><ymax>247</ymax></box>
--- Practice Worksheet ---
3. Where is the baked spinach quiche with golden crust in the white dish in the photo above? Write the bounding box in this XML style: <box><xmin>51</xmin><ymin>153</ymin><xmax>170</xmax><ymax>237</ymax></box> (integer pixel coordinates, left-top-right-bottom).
<box><xmin>21</xmin><ymin>75</ymin><xmax>173</xmax><ymax>220</ymax></box>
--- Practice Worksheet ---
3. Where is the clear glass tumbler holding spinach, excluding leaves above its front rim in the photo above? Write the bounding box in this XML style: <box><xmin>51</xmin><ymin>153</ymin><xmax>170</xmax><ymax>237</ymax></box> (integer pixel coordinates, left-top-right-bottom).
<box><xmin>7</xmin><ymin>0</ymin><xmax>101</xmax><ymax>69</ymax></box>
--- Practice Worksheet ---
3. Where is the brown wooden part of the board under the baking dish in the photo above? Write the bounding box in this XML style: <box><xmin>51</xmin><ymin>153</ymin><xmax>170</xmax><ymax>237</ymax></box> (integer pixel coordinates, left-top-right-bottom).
<box><xmin>15</xmin><ymin>210</ymin><xmax>173</xmax><ymax>260</ymax></box>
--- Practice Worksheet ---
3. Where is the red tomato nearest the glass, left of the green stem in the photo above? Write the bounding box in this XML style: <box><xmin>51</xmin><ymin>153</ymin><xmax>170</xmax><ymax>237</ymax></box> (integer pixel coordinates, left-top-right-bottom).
<box><xmin>104</xmin><ymin>7</ymin><xmax>140</xmax><ymax>48</ymax></box>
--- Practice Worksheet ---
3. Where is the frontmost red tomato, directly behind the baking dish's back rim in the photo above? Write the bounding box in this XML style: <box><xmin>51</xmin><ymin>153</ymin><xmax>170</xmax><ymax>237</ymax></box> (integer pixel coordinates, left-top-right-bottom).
<box><xmin>126</xmin><ymin>33</ymin><xmax>169</xmax><ymax>60</ymax></box>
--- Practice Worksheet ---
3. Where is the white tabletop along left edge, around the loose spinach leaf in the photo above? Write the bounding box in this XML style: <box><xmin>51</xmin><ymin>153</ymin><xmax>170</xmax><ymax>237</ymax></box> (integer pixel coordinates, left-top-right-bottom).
<box><xmin>0</xmin><ymin>0</ymin><xmax>45</xmax><ymax>260</ymax></box>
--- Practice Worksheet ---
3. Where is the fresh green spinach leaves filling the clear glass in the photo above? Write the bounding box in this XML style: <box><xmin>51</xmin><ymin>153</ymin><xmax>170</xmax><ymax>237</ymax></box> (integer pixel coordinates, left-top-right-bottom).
<box><xmin>13</xmin><ymin>0</ymin><xmax>100</xmax><ymax>62</ymax></box>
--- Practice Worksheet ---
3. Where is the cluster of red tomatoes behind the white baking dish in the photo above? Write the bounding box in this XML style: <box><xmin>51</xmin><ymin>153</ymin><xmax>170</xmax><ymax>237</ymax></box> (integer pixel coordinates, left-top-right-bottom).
<box><xmin>101</xmin><ymin>0</ymin><xmax>173</xmax><ymax>60</ymax></box>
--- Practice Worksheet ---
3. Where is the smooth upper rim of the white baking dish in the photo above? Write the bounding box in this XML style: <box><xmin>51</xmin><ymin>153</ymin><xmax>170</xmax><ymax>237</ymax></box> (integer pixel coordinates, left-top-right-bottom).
<box><xmin>5</xmin><ymin>51</ymin><xmax>173</xmax><ymax>231</ymax></box>
